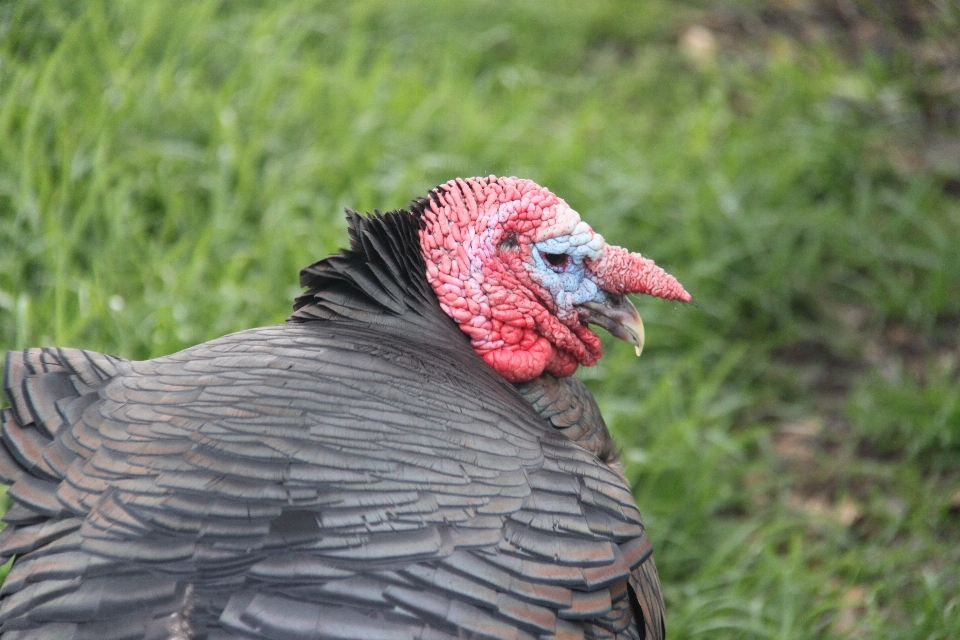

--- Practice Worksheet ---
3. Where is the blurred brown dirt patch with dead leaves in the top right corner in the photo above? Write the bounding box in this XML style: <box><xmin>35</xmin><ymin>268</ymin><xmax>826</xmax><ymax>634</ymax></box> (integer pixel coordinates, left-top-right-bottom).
<box><xmin>677</xmin><ymin>0</ymin><xmax>960</xmax><ymax>198</ymax></box>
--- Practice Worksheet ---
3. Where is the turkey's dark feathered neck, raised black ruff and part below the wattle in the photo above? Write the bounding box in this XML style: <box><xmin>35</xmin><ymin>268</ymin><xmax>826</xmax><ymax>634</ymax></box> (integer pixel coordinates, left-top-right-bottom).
<box><xmin>287</xmin><ymin>209</ymin><xmax>622</xmax><ymax>468</ymax></box>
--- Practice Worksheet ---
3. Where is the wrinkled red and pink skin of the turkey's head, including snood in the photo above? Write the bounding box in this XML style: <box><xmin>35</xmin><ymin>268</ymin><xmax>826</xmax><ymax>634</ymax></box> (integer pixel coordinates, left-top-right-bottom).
<box><xmin>420</xmin><ymin>176</ymin><xmax>690</xmax><ymax>382</ymax></box>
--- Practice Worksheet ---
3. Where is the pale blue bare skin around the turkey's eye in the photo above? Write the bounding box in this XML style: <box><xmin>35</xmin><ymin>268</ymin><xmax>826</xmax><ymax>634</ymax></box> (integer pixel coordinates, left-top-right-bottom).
<box><xmin>527</xmin><ymin>236</ymin><xmax>605</xmax><ymax>320</ymax></box>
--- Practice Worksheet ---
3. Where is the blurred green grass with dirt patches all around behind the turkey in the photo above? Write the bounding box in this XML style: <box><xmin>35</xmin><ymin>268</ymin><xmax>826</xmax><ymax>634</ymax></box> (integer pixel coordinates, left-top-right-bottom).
<box><xmin>0</xmin><ymin>0</ymin><xmax>960</xmax><ymax>639</ymax></box>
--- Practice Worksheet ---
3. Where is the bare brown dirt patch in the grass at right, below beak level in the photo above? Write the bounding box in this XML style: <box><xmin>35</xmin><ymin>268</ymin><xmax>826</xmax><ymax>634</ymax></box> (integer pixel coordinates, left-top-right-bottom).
<box><xmin>758</xmin><ymin>306</ymin><xmax>960</xmax><ymax>538</ymax></box>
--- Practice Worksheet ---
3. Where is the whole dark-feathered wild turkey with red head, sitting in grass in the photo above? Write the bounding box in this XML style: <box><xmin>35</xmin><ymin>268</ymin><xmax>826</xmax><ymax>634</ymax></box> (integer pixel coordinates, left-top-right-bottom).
<box><xmin>0</xmin><ymin>176</ymin><xmax>690</xmax><ymax>640</ymax></box>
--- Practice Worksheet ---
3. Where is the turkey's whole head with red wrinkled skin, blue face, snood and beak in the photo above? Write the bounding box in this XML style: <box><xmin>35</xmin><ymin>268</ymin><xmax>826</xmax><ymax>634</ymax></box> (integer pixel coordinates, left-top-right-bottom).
<box><xmin>412</xmin><ymin>176</ymin><xmax>691</xmax><ymax>382</ymax></box>
